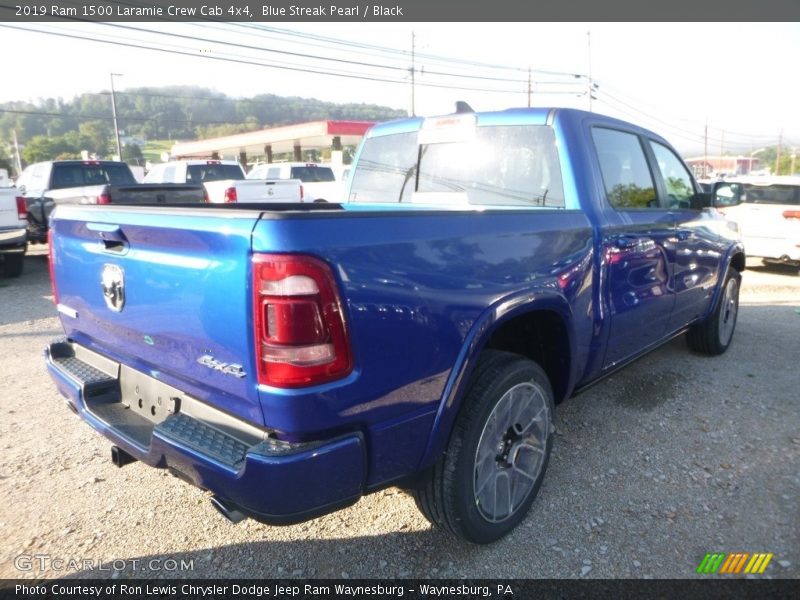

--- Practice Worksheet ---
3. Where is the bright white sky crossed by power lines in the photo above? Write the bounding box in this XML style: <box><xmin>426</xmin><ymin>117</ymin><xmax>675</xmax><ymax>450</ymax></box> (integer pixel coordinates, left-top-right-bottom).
<box><xmin>0</xmin><ymin>23</ymin><xmax>800</xmax><ymax>153</ymax></box>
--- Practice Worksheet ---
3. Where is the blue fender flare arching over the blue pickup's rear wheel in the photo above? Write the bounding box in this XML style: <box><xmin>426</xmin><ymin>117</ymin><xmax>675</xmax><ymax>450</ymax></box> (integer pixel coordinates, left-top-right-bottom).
<box><xmin>418</xmin><ymin>289</ymin><xmax>576</xmax><ymax>470</ymax></box>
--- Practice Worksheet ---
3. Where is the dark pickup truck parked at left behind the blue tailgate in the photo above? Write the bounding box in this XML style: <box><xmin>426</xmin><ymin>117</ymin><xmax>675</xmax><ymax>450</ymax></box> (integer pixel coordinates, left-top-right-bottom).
<box><xmin>17</xmin><ymin>160</ymin><xmax>205</xmax><ymax>243</ymax></box>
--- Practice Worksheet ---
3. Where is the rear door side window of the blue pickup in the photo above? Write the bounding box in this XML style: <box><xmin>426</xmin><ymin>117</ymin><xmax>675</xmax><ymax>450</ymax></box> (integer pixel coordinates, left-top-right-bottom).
<box><xmin>592</xmin><ymin>127</ymin><xmax>660</xmax><ymax>209</ymax></box>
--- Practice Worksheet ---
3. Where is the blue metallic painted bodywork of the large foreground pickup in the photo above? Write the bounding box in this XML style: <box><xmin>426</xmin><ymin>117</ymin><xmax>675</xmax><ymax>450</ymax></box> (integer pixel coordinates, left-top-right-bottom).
<box><xmin>50</xmin><ymin>109</ymin><xmax>738</xmax><ymax>514</ymax></box>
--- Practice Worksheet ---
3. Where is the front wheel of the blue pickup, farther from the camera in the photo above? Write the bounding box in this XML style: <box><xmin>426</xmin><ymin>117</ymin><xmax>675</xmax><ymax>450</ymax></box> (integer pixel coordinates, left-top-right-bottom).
<box><xmin>686</xmin><ymin>267</ymin><xmax>742</xmax><ymax>356</ymax></box>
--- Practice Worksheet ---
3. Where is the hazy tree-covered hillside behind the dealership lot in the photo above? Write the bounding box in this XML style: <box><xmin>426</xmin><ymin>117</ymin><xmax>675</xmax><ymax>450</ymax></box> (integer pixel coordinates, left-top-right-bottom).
<box><xmin>0</xmin><ymin>86</ymin><xmax>406</xmax><ymax>168</ymax></box>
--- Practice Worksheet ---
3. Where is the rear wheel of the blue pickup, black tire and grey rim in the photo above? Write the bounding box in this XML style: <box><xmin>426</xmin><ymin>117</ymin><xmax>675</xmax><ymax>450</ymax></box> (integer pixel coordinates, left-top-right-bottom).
<box><xmin>413</xmin><ymin>350</ymin><xmax>553</xmax><ymax>544</ymax></box>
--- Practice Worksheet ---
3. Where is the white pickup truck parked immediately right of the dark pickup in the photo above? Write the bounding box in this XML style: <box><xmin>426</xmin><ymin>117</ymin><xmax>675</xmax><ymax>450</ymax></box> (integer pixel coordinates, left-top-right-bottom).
<box><xmin>144</xmin><ymin>160</ymin><xmax>303</xmax><ymax>204</ymax></box>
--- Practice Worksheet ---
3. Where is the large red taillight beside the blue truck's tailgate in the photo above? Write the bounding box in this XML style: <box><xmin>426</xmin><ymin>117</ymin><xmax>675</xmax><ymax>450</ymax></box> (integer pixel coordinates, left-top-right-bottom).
<box><xmin>253</xmin><ymin>254</ymin><xmax>353</xmax><ymax>388</ymax></box>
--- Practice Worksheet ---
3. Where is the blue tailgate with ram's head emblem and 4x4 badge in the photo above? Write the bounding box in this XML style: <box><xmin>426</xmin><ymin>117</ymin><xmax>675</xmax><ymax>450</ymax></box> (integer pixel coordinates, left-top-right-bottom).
<box><xmin>51</xmin><ymin>205</ymin><xmax>263</xmax><ymax>425</ymax></box>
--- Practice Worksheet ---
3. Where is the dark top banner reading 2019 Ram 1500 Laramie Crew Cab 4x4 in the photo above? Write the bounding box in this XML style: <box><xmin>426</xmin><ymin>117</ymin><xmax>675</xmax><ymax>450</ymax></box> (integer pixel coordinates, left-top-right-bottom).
<box><xmin>0</xmin><ymin>0</ymin><xmax>800</xmax><ymax>22</ymax></box>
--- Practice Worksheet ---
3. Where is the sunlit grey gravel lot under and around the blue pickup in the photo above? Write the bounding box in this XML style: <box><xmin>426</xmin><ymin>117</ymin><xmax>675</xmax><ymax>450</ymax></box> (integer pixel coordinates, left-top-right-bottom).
<box><xmin>0</xmin><ymin>247</ymin><xmax>800</xmax><ymax>578</ymax></box>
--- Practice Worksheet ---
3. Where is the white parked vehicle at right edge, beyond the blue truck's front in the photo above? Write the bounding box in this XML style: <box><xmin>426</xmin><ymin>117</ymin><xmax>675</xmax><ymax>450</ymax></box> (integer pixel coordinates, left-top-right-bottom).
<box><xmin>714</xmin><ymin>176</ymin><xmax>800</xmax><ymax>267</ymax></box>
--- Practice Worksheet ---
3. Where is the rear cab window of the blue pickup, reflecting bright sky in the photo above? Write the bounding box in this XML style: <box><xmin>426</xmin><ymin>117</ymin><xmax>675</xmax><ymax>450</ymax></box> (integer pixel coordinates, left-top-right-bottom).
<box><xmin>349</xmin><ymin>115</ymin><xmax>565</xmax><ymax>208</ymax></box>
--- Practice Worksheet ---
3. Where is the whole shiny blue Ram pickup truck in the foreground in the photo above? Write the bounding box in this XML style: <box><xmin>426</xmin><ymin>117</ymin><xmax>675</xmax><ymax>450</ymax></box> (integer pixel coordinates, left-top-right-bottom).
<box><xmin>46</xmin><ymin>109</ymin><xmax>745</xmax><ymax>543</ymax></box>
